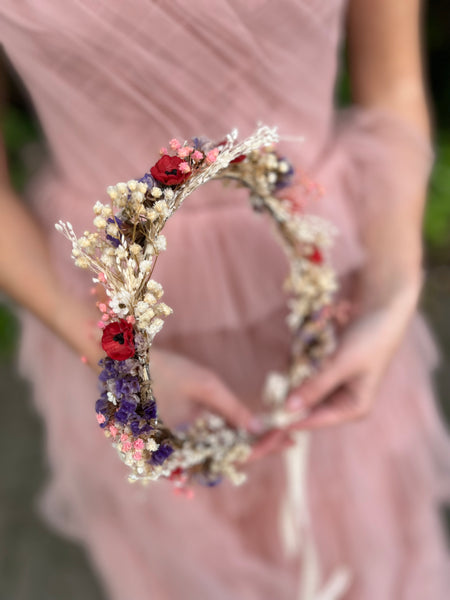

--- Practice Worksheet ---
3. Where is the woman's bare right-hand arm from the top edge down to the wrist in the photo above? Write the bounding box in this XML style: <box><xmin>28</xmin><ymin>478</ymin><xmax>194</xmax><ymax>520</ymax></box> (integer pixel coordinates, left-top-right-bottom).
<box><xmin>348</xmin><ymin>0</ymin><xmax>431</xmax><ymax>308</ymax></box>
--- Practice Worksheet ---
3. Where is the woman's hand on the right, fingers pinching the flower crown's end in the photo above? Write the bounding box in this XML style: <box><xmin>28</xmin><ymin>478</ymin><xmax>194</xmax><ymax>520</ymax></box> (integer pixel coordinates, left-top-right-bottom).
<box><xmin>288</xmin><ymin>274</ymin><xmax>420</xmax><ymax>430</ymax></box>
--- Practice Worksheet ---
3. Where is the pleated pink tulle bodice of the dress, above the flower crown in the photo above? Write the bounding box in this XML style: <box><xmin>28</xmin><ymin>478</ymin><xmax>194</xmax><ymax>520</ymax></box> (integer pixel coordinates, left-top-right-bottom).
<box><xmin>0</xmin><ymin>0</ymin><xmax>345</xmax><ymax>192</ymax></box>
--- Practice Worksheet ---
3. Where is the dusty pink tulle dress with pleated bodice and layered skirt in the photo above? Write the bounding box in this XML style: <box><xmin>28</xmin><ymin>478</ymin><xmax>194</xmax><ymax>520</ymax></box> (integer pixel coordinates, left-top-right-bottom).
<box><xmin>0</xmin><ymin>0</ymin><xmax>450</xmax><ymax>600</ymax></box>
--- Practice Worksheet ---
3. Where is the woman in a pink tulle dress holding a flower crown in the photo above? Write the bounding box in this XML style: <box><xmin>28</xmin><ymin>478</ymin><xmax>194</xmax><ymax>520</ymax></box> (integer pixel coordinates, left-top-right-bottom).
<box><xmin>0</xmin><ymin>0</ymin><xmax>450</xmax><ymax>600</ymax></box>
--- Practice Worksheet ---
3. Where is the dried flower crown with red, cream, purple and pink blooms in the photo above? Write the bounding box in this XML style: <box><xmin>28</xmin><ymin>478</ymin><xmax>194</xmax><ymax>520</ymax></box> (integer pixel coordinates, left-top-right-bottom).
<box><xmin>56</xmin><ymin>126</ymin><xmax>337</xmax><ymax>488</ymax></box>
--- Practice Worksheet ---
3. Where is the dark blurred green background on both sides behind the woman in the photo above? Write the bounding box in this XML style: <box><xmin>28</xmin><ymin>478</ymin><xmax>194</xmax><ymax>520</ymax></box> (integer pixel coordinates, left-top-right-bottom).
<box><xmin>0</xmin><ymin>0</ymin><xmax>450</xmax><ymax>600</ymax></box>
